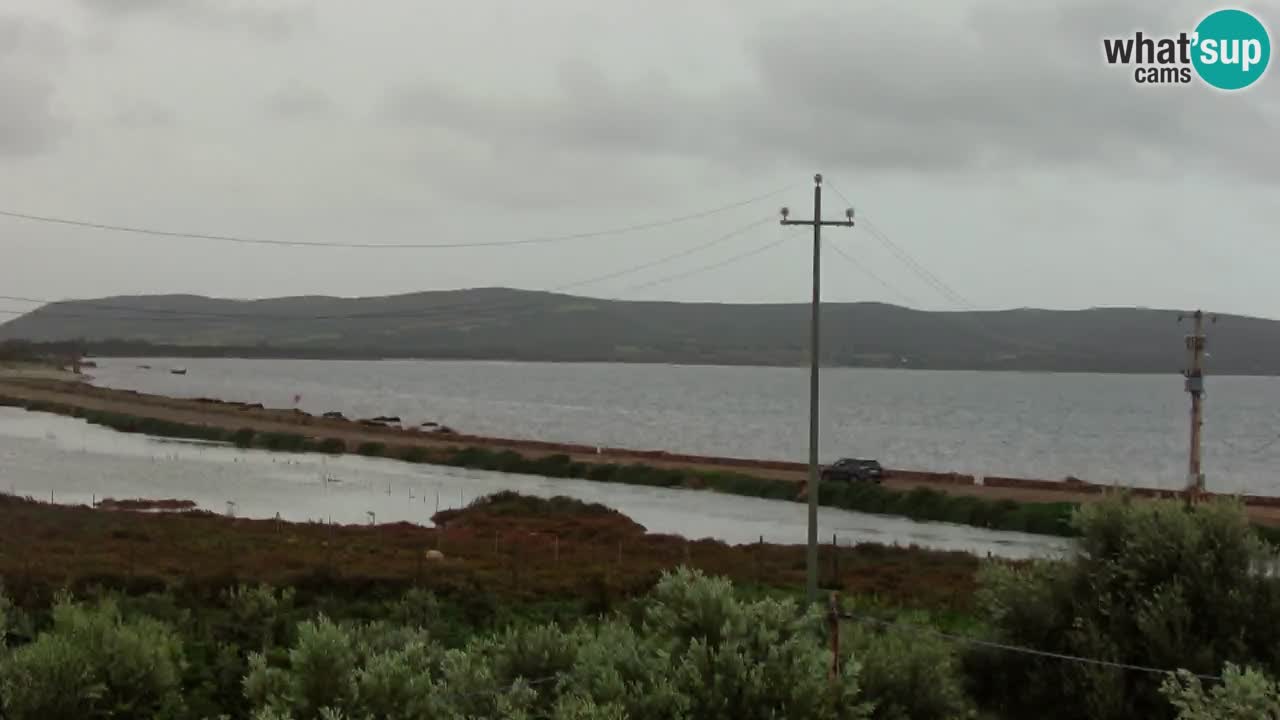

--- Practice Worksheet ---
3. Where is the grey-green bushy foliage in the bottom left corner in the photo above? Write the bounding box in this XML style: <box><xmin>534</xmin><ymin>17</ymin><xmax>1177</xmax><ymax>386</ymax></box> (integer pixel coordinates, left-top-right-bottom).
<box><xmin>0</xmin><ymin>589</ymin><xmax>184</xmax><ymax>720</ymax></box>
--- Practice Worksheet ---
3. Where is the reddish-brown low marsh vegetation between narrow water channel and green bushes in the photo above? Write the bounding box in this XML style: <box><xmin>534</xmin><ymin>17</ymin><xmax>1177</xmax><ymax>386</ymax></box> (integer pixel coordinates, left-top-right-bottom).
<box><xmin>0</xmin><ymin>496</ymin><xmax>978</xmax><ymax>609</ymax></box>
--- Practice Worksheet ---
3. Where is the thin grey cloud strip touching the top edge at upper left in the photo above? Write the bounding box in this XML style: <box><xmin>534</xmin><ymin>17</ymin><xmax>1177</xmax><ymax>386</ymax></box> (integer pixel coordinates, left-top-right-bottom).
<box><xmin>79</xmin><ymin>0</ymin><xmax>311</xmax><ymax>38</ymax></box>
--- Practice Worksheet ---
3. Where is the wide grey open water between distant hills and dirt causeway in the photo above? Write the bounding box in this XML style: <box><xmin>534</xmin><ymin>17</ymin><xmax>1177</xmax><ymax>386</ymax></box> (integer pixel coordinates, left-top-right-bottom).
<box><xmin>91</xmin><ymin>359</ymin><xmax>1280</xmax><ymax>495</ymax></box>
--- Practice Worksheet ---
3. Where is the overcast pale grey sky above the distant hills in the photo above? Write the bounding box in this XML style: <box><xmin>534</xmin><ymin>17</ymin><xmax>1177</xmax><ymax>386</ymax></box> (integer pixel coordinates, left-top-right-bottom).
<box><xmin>0</xmin><ymin>0</ymin><xmax>1280</xmax><ymax>318</ymax></box>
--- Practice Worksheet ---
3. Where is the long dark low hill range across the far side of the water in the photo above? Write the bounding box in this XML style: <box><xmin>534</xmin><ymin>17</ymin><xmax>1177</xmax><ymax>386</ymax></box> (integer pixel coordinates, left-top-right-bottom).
<box><xmin>0</xmin><ymin>288</ymin><xmax>1280</xmax><ymax>375</ymax></box>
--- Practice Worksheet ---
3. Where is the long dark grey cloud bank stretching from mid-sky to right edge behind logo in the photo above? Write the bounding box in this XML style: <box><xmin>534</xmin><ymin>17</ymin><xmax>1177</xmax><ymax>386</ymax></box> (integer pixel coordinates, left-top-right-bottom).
<box><xmin>378</xmin><ymin>0</ymin><xmax>1280</xmax><ymax>182</ymax></box>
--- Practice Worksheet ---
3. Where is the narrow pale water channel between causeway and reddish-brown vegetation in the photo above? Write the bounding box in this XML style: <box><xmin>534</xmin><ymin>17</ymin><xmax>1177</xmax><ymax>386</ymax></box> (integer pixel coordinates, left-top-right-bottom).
<box><xmin>0</xmin><ymin>407</ymin><xmax>1066</xmax><ymax>557</ymax></box>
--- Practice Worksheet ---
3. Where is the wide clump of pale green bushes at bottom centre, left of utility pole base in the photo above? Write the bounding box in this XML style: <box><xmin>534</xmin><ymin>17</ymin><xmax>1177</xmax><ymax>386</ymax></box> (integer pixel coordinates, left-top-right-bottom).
<box><xmin>244</xmin><ymin>570</ymin><xmax>868</xmax><ymax>720</ymax></box>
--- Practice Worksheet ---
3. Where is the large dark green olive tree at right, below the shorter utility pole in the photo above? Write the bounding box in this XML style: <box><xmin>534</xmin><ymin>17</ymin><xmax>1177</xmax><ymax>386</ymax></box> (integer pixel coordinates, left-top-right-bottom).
<box><xmin>969</xmin><ymin>497</ymin><xmax>1280</xmax><ymax>720</ymax></box>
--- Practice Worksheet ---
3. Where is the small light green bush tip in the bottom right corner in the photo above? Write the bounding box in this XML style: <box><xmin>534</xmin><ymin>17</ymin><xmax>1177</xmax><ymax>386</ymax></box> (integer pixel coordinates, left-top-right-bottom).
<box><xmin>1161</xmin><ymin>664</ymin><xmax>1280</xmax><ymax>720</ymax></box>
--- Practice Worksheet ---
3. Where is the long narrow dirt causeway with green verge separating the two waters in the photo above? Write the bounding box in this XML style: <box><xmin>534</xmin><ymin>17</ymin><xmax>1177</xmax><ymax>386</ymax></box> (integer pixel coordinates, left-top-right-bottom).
<box><xmin>0</xmin><ymin>374</ymin><xmax>1280</xmax><ymax>536</ymax></box>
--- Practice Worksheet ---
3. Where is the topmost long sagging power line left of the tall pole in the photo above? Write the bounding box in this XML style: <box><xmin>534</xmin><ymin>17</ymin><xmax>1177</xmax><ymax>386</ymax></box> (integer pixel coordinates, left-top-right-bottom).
<box><xmin>0</xmin><ymin>184</ymin><xmax>794</xmax><ymax>250</ymax></box>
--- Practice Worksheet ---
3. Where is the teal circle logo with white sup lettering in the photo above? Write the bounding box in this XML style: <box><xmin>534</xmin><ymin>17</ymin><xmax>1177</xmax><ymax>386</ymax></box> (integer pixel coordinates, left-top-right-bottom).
<box><xmin>1192</xmin><ymin>10</ymin><xmax>1271</xmax><ymax>90</ymax></box>
